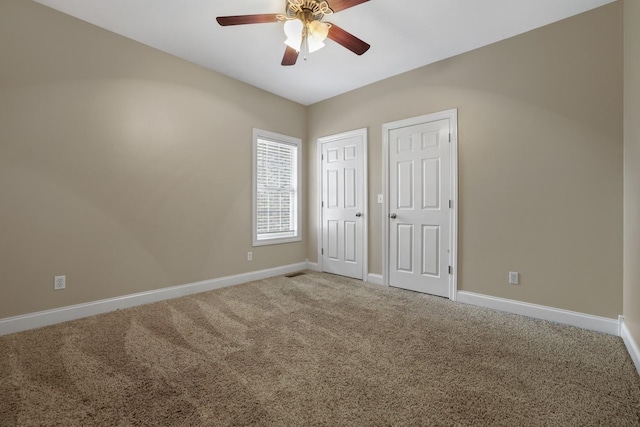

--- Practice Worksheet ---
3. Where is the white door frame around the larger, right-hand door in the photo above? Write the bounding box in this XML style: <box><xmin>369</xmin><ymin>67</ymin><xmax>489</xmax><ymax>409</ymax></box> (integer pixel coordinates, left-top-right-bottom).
<box><xmin>382</xmin><ymin>108</ymin><xmax>458</xmax><ymax>301</ymax></box>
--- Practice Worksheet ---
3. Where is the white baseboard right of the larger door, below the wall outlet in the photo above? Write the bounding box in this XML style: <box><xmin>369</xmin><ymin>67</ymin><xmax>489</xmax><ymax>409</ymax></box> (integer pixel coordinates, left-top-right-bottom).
<box><xmin>457</xmin><ymin>291</ymin><xmax>619</xmax><ymax>335</ymax></box>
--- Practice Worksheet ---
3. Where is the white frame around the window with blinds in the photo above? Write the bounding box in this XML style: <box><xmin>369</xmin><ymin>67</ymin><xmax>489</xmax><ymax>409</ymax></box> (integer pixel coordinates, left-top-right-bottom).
<box><xmin>251</xmin><ymin>128</ymin><xmax>302</xmax><ymax>246</ymax></box>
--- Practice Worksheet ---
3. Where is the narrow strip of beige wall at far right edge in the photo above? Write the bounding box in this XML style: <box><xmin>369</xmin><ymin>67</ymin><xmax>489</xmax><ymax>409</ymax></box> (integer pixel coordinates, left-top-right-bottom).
<box><xmin>624</xmin><ymin>0</ymin><xmax>640</xmax><ymax>343</ymax></box>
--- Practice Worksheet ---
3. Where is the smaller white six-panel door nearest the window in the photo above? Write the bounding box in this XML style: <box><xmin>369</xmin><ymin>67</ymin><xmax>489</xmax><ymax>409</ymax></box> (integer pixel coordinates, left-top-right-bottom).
<box><xmin>318</xmin><ymin>129</ymin><xmax>366</xmax><ymax>280</ymax></box>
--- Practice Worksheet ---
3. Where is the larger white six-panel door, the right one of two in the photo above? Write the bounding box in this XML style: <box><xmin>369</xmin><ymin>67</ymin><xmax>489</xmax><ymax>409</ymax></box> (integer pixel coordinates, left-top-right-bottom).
<box><xmin>385</xmin><ymin>110</ymin><xmax>454</xmax><ymax>297</ymax></box>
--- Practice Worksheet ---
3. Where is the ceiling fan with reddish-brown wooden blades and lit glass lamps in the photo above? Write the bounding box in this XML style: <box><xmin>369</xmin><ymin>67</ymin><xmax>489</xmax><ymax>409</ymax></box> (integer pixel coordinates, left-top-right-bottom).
<box><xmin>216</xmin><ymin>0</ymin><xmax>371</xmax><ymax>65</ymax></box>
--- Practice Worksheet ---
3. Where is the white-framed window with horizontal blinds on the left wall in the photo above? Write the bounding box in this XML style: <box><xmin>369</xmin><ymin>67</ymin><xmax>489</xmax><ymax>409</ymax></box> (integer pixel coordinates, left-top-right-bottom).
<box><xmin>253</xmin><ymin>129</ymin><xmax>301</xmax><ymax>246</ymax></box>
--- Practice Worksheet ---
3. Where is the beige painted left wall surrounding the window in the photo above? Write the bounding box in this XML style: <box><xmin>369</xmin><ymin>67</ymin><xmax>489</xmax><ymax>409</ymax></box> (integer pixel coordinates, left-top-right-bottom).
<box><xmin>0</xmin><ymin>0</ymin><xmax>306</xmax><ymax>318</ymax></box>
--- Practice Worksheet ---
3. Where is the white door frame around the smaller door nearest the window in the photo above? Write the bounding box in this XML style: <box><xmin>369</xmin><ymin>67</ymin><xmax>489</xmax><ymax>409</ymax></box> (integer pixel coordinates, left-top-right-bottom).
<box><xmin>316</xmin><ymin>128</ymin><xmax>369</xmax><ymax>282</ymax></box>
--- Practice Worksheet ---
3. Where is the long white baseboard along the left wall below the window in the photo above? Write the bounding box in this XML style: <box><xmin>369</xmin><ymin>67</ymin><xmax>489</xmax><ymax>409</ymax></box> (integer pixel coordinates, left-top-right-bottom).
<box><xmin>0</xmin><ymin>262</ymin><xmax>309</xmax><ymax>336</ymax></box>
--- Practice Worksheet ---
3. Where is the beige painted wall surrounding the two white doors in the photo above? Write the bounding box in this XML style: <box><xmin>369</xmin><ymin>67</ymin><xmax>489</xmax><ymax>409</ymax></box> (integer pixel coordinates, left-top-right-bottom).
<box><xmin>307</xmin><ymin>2</ymin><xmax>623</xmax><ymax>318</ymax></box>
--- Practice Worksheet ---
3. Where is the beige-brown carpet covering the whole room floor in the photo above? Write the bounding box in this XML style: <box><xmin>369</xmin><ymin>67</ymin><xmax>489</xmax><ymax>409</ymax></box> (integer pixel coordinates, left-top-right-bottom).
<box><xmin>0</xmin><ymin>272</ymin><xmax>640</xmax><ymax>426</ymax></box>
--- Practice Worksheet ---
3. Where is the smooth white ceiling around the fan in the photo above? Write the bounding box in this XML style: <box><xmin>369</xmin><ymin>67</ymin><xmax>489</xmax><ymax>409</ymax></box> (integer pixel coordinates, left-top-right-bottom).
<box><xmin>36</xmin><ymin>0</ymin><xmax>615</xmax><ymax>105</ymax></box>
